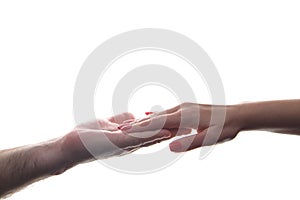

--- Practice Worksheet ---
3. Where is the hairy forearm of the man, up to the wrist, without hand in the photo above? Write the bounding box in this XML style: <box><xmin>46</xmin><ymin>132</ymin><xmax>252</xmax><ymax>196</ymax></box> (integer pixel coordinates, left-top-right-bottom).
<box><xmin>0</xmin><ymin>139</ymin><xmax>74</xmax><ymax>197</ymax></box>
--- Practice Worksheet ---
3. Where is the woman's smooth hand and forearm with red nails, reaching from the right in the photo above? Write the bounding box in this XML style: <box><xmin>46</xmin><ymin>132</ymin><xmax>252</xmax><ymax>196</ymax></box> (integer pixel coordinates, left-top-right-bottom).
<box><xmin>119</xmin><ymin>100</ymin><xmax>300</xmax><ymax>152</ymax></box>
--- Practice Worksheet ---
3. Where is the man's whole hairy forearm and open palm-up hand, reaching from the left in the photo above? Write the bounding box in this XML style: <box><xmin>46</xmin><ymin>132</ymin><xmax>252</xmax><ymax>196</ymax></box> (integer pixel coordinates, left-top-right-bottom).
<box><xmin>0</xmin><ymin>113</ymin><xmax>183</xmax><ymax>197</ymax></box>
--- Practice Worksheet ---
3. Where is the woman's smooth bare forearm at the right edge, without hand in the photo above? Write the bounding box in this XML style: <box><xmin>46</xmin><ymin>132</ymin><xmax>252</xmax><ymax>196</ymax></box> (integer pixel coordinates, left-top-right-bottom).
<box><xmin>237</xmin><ymin>100</ymin><xmax>300</xmax><ymax>135</ymax></box>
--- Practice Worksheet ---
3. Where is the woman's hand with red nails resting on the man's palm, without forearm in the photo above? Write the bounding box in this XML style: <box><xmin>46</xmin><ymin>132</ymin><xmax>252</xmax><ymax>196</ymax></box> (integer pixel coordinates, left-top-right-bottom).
<box><xmin>119</xmin><ymin>103</ymin><xmax>241</xmax><ymax>152</ymax></box>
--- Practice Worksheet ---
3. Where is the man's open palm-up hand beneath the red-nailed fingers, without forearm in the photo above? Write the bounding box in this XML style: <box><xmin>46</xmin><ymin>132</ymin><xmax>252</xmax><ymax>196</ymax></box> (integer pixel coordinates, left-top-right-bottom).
<box><xmin>62</xmin><ymin>113</ymin><xmax>176</xmax><ymax>164</ymax></box>
